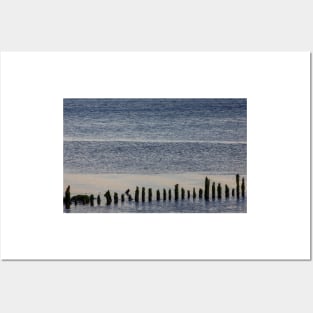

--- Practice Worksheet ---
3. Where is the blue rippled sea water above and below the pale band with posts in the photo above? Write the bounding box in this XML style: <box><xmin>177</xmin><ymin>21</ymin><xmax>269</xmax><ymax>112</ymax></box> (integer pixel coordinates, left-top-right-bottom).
<box><xmin>64</xmin><ymin>99</ymin><xmax>247</xmax><ymax>212</ymax></box>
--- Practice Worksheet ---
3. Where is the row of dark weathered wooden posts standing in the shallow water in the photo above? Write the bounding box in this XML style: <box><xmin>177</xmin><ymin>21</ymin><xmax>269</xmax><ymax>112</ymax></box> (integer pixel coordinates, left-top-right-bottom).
<box><xmin>64</xmin><ymin>174</ymin><xmax>246</xmax><ymax>209</ymax></box>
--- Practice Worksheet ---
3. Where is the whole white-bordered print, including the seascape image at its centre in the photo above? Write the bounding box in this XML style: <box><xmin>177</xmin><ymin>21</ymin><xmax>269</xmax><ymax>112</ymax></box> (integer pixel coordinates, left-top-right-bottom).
<box><xmin>1</xmin><ymin>52</ymin><xmax>311</xmax><ymax>260</ymax></box>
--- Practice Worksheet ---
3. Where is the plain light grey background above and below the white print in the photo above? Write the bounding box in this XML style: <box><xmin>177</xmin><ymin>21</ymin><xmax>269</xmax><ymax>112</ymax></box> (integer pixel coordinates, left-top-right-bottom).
<box><xmin>0</xmin><ymin>0</ymin><xmax>313</xmax><ymax>313</ymax></box>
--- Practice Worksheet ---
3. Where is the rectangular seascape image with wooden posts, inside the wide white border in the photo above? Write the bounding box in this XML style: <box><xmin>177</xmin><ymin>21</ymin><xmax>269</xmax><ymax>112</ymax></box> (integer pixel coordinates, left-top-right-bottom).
<box><xmin>63</xmin><ymin>98</ymin><xmax>247</xmax><ymax>213</ymax></box>
